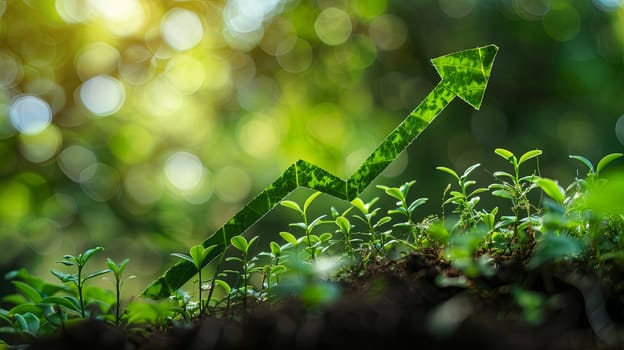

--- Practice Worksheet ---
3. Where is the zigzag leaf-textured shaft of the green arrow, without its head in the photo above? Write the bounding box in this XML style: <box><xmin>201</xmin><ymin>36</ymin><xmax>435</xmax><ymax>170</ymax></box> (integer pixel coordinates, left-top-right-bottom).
<box><xmin>143</xmin><ymin>81</ymin><xmax>455</xmax><ymax>298</ymax></box>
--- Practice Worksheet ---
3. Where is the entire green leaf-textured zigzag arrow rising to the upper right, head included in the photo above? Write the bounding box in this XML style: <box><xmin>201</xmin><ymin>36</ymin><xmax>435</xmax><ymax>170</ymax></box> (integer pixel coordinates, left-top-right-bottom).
<box><xmin>142</xmin><ymin>45</ymin><xmax>498</xmax><ymax>299</ymax></box>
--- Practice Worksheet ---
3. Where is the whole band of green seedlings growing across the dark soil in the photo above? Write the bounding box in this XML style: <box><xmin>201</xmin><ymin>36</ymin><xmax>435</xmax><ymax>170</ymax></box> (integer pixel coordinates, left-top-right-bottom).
<box><xmin>0</xmin><ymin>148</ymin><xmax>624</xmax><ymax>348</ymax></box>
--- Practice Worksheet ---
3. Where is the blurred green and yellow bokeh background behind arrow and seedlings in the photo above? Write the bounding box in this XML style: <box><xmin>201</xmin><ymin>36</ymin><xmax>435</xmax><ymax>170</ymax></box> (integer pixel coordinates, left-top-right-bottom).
<box><xmin>0</xmin><ymin>0</ymin><xmax>624</xmax><ymax>291</ymax></box>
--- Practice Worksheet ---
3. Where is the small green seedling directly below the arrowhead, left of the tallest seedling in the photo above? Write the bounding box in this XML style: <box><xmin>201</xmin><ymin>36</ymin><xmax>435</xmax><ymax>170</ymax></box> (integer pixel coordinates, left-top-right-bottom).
<box><xmin>436</xmin><ymin>163</ymin><xmax>489</xmax><ymax>231</ymax></box>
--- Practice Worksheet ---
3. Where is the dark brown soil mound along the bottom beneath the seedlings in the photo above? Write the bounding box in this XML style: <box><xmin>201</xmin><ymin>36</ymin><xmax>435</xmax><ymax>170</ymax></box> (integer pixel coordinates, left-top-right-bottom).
<box><xmin>28</xmin><ymin>254</ymin><xmax>624</xmax><ymax>350</ymax></box>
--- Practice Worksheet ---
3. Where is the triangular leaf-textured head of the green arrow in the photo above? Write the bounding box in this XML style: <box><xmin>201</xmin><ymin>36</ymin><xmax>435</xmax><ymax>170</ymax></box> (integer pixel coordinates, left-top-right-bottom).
<box><xmin>431</xmin><ymin>45</ymin><xmax>498</xmax><ymax>109</ymax></box>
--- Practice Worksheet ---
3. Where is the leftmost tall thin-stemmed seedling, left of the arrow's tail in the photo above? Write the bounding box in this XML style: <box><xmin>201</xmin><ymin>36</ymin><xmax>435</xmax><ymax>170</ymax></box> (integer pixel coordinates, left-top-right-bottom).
<box><xmin>51</xmin><ymin>247</ymin><xmax>111</xmax><ymax>318</ymax></box>
